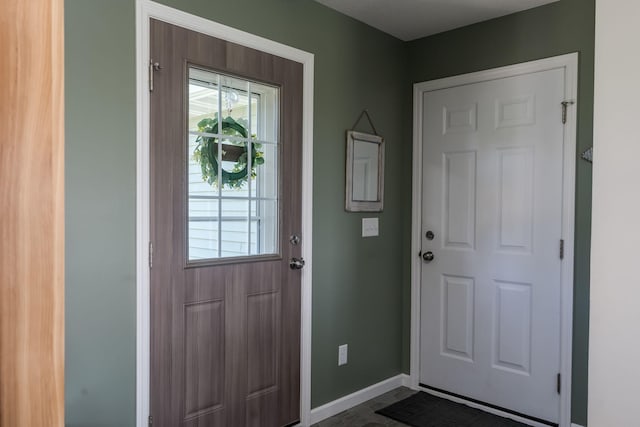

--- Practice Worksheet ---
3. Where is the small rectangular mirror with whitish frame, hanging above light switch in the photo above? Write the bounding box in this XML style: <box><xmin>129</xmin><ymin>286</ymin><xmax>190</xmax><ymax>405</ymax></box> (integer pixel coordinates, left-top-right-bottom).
<box><xmin>345</xmin><ymin>131</ymin><xmax>384</xmax><ymax>212</ymax></box>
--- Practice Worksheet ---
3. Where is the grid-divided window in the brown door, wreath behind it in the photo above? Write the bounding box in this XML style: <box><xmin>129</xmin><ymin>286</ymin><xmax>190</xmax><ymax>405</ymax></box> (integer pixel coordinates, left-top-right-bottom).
<box><xmin>187</xmin><ymin>67</ymin><xmax>279</xmax><ymax>261</ymax></box>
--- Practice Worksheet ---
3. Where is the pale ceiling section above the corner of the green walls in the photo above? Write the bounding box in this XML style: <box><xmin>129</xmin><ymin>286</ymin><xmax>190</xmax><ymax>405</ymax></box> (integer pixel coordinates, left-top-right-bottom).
<box><xmin>315</xmin><ymin>0</ymin><xmax>558</xmax><ymax>41</ymax></box>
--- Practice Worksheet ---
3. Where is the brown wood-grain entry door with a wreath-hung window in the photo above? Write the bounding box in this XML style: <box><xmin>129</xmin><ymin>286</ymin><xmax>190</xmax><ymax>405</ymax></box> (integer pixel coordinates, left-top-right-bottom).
<box><xmin>150</xmin><ymin>20</ymin><xmax>303</xmax><ymax>427</ymax></box>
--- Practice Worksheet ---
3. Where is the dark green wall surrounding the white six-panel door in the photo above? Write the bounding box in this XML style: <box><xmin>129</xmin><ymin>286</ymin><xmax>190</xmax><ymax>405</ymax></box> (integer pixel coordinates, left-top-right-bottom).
<box><xmin>403</xmin><ymin>0</ymin><xmax>595</xmax><ymax>426</ymax></box>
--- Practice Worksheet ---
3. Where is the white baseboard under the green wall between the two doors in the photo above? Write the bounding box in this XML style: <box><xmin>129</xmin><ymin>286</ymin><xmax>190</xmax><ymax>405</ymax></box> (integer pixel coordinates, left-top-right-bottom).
<box><xmin>310</xmin><ymin>374</ymin><xmax>409</xmax><ymax>424</ymax></box>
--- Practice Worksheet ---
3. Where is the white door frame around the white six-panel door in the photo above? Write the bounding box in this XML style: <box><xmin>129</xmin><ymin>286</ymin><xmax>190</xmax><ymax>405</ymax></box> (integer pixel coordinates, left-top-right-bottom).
<box><xmin>410</xmin><ymin>53</ymin><xmax>578</xmax><ymax>427</ymax></box>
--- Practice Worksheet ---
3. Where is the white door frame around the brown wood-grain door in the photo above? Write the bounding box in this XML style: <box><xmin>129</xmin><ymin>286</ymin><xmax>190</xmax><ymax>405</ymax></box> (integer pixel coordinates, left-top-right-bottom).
<box><xmin>136</xmin><ymin>0</ymin><xmax>314</xmax><ymax>427</ymax></box>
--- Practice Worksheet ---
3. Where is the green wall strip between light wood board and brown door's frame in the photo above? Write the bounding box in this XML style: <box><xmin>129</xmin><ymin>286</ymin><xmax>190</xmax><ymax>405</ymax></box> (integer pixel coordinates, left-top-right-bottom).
<box><xmin>65</xmin><ymin>0</ymin><xmax>136</xmax><ymax>427</ymax></box>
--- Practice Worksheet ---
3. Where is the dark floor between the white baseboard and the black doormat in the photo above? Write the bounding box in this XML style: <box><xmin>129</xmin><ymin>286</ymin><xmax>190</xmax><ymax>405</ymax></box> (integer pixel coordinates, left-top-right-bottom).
<box><xmin>311</xmin><ymin>387</ymin><xmax>416</xmax><ymax>427</ymax></box>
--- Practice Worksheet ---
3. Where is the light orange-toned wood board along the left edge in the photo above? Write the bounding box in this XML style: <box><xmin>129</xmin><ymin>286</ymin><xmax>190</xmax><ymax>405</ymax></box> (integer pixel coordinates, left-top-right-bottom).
<box><xmin>0</xmin><ymin>0</ymin><xmax>64</xmax><ymax>427</ymax></box>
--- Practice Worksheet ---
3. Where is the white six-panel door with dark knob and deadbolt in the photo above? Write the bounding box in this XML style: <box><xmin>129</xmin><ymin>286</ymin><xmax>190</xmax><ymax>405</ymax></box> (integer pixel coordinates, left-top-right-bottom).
<box><xmin>420</xmin><ymin>69</ymin><xmax>565</xmax><ymax>423</ymax></box>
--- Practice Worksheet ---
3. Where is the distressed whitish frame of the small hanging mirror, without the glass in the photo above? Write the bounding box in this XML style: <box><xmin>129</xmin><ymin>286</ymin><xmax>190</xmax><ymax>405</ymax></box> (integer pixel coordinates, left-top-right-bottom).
<box><xmin>345</xmin><ymin>130</ymin><xmax>384</xmax><ymax>212</ymax></box>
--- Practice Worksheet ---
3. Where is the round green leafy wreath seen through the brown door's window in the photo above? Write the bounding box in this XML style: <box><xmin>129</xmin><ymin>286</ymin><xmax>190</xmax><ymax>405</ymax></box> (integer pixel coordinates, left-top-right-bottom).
<box><xmin>193</xmin><ymin>114</ymin><xmax>264</xmax><ymax>188</ymax></box>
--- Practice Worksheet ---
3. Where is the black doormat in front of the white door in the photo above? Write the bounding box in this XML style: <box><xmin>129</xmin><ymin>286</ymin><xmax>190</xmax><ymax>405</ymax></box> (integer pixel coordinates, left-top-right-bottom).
<box><xmin>376</xmin><ymin>391</ymin><xmax>528</xmax><ymax>427</ymax></box>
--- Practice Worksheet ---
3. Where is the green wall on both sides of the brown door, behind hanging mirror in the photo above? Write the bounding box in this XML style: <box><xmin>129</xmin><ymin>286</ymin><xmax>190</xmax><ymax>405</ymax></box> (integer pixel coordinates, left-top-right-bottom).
<box><xmin>65</xmin><ymin>0</ymin><xmax>410</xmax><ymax>427</ymax></box>
